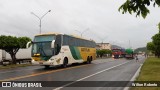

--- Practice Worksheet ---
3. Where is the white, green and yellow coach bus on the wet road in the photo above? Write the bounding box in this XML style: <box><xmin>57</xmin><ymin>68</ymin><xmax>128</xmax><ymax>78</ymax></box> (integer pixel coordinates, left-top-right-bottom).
<box><xmin>27</xmin><ymin>33</ymin><xmax>96</xmax><ymax>68</ymax></box>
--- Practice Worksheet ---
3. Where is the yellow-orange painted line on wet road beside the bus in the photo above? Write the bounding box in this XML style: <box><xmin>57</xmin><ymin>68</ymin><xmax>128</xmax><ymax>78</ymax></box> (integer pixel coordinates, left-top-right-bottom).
<box><xmin>0</xmin><ymin>64</ymin><xmax>90</xmax><ymax>82</ymax></box>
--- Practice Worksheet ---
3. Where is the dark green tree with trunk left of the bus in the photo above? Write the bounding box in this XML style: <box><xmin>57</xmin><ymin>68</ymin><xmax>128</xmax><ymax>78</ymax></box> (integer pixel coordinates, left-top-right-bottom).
<box><xmin>0</xmin><ymin>35</ymin><xmax>31</xmax><ymax>64</ymax></box>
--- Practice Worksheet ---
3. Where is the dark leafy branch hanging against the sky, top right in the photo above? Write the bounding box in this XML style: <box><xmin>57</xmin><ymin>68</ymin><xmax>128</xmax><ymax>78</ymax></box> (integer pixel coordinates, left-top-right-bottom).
<box><xmin>119</xmin><ymin>0</ymin><xmax>160</xmax><ymax>18</ymax></box>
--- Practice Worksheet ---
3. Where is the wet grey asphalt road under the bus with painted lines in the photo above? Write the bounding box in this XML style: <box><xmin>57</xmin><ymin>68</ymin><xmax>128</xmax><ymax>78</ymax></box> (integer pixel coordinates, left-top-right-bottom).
<box><xmin>0</xmin><ymin>56</ymin><xmax>145</xmax><ymax>90</ymax></box>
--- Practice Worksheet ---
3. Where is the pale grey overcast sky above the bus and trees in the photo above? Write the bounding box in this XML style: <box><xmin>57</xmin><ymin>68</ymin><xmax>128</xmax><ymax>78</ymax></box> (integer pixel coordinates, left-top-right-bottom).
<box><xmin>0</xmin><ymin>0</ymin><xmax>160</xmax><ymax>48</ymax></box>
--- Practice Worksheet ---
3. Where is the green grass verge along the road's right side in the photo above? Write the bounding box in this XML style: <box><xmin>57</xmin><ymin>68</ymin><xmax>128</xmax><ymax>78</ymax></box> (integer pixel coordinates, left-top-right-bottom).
<box><xmin>130</xmin><ymin>57</ymin><xmax>160</xmax><ymax>90</ymax></box>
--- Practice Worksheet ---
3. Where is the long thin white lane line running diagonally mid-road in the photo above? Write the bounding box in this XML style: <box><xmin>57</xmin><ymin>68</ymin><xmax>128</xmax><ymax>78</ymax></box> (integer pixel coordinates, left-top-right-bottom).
<box><xmin>53</xmin><ymin>61</ymin><xmax>130</xmax><ymax>90</ymax></box>
